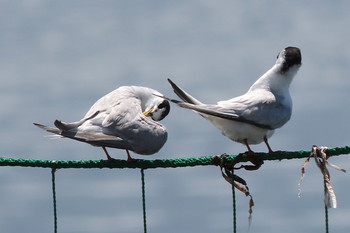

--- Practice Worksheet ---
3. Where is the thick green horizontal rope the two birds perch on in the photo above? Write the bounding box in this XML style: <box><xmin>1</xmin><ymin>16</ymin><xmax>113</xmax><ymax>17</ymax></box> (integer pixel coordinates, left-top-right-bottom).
<box><xmin>0</xmin><ymin>146</ymin><xmax>350</xmax><ymax>169</ymax></box>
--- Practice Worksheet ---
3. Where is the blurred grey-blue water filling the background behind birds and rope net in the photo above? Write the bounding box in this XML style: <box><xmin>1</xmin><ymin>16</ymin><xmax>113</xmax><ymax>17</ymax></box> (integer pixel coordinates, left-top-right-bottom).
<box><xmin>0</xmin><ymin>0</ymin><xmax>350</xmax><ymax>233</ymax></box>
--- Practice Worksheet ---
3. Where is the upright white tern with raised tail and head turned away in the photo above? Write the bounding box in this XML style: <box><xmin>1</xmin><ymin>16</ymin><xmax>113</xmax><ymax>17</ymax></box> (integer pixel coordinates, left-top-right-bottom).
<box><xmin>168</xmin><ymin>47</ymin><xmax>301</xmax><ymax>154</ymax></box>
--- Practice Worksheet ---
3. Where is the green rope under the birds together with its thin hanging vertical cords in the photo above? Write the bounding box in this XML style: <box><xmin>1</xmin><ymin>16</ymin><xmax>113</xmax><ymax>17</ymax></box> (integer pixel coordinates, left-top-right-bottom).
<box><xmin>0</xmin><ymin>146</ymin><xmax>350</xmax><ymax>233</ymax></box>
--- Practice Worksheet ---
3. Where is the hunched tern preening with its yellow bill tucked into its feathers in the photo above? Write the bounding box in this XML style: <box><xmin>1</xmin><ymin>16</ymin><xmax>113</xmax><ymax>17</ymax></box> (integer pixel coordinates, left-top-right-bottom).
<box><xmin>34</xmin><ymin>86</ymin><xmax>170</xmax><ymax>161</ymax></box>
